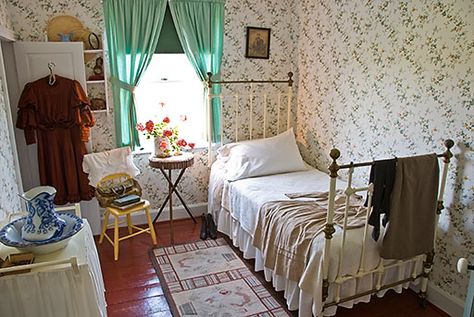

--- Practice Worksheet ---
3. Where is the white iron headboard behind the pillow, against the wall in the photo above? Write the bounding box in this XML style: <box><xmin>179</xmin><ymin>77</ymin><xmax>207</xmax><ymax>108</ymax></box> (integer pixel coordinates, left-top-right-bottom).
<box><xmin>207</xmin><ymin>72</ymin><xmax>294</xmax><ymax>166</ymax></box>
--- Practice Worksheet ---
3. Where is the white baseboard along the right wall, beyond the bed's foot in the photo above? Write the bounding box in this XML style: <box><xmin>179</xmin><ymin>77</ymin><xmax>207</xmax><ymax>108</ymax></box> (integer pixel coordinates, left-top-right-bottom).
<box><xmin>410</xmin><ymin>282</ymin><xmax>464</xmax><ymax>317</ymax></box>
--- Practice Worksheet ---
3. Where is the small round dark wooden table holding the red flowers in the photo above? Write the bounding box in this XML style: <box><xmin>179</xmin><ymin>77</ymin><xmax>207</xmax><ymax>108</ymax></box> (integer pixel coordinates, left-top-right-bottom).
<box><xmin>148</xmin><ymin>153</ymin><xmax>196</xmax><ymax>244</ymax></box>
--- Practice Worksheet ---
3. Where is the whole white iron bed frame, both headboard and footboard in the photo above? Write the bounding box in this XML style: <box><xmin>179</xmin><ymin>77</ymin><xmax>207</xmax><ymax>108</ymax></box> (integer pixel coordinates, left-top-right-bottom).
<box><xmin>206</xmin><ymin>72</ymin><xmax>454</xmax><ymax>309</ymax></box>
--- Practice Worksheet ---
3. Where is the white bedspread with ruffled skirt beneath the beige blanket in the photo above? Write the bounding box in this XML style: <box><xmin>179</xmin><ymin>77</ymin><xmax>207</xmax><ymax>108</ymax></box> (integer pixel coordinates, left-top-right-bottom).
<box><xmin>208</xmin><ymin>160</ymin><xmax>421</xmax><ymax>316</ymax></box>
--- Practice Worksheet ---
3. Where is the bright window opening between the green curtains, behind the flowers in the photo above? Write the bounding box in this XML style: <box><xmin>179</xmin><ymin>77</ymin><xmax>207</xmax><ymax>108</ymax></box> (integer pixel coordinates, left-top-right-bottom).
<box><xmin>135</xmin><ymin>54</ymin><xmax>206</xmax><ymax>152</ymax></box>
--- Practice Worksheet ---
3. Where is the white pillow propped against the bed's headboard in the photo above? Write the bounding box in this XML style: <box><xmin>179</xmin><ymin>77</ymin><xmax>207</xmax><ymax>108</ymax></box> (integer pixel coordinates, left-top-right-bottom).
<box><xmin>218</xmin><ymin>129</ymin><xmax>307</xmax><ymax>181</ymax></box>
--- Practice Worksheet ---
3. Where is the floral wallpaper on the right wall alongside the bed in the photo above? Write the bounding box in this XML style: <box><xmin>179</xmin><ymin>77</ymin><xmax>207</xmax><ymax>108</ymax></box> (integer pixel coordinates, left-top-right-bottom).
<box><xmin>297</xmin><ymin>0</ymin><xmax>474</xmax><ymax>298</ymax></box>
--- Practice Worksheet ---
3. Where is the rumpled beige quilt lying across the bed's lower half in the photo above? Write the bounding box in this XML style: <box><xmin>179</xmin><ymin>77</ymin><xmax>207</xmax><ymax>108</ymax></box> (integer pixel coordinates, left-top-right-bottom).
<box><xmin>253</xmin><ymin>191</ymin><xmax>366</xmax><ymax>282</ymax></box>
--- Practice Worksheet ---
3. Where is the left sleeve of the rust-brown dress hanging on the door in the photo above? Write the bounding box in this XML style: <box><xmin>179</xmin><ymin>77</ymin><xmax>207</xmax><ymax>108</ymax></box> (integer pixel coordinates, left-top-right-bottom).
<box><xmin>16</xmin><ymin>83</ymin><xmax>37</xmax><ymax>144</ymax></box>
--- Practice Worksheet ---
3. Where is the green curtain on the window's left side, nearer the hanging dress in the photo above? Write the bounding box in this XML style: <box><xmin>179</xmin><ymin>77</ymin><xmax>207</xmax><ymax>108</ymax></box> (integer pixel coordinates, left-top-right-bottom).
<box><xmin>104</xmin><ymin>0</ymin><xmax>166</xmax><ymax>148</ymax></box>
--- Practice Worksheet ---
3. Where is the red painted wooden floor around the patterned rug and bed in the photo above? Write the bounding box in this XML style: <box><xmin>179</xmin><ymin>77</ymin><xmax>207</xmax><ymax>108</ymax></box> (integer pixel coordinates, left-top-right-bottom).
<box><xmin>96</xmin><ymin>219</ymin><xmax>448</xmax><ymax>317</ymax></box>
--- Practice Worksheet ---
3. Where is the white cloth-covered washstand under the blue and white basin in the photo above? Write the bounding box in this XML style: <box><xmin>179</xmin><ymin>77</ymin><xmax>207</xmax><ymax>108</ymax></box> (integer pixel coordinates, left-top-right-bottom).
<box><xmin>0</xmin><ymin>219</ymin><xmax>107</xmax><ymax>317</ymax></box>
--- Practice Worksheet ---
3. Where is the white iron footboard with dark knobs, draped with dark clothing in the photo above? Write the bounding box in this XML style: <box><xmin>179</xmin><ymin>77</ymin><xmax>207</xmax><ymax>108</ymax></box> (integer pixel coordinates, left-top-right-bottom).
<box><xmin>322</xmin><ymin>139</ymin><xmax>454</xmax><ymax>308</ymax></box>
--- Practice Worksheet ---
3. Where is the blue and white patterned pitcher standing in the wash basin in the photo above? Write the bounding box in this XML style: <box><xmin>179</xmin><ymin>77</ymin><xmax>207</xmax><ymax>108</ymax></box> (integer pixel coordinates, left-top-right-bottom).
<box><xmin>21</xmin><ymin>186</ymin><xmax>66</xmax><ymax>241</ymax></box>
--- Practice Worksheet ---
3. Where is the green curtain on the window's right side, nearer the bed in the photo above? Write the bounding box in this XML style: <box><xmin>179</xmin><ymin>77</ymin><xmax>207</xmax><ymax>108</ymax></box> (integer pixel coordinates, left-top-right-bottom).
<box><xmin>169</xmin><ymin>0</ymin><xmax>225</xmax><ymax>142</ymax></box>
